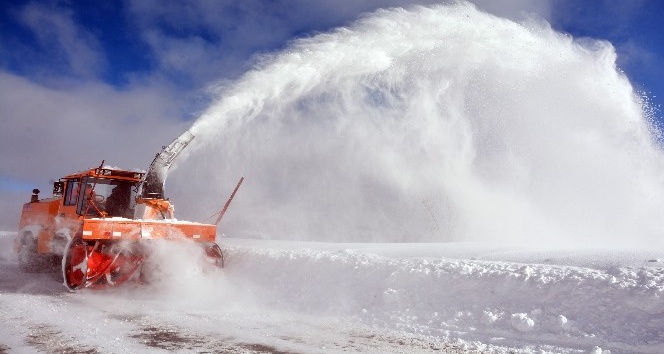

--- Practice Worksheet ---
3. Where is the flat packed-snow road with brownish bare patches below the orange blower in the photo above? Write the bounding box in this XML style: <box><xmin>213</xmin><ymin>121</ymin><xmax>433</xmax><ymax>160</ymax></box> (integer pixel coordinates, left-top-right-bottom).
<box><xmin>0</xmin><ymin>262</ymin><xmax>455</xmax><ymax>353</ymax></box>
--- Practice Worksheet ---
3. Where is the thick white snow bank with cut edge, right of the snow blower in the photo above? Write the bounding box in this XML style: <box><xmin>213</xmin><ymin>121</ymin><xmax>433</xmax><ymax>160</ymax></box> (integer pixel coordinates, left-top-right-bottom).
<box><xmin>226</xmin><ymin>240</ymin><xmax>664</xmax><ymax>353</ymax></box>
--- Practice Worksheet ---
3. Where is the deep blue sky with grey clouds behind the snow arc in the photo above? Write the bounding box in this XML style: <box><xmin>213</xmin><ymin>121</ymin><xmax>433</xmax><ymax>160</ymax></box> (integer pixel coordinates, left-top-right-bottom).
<box><xmin>0</xmin><ymin>0</ymin><xmax>664</xmax><ymax>227</ymax></box>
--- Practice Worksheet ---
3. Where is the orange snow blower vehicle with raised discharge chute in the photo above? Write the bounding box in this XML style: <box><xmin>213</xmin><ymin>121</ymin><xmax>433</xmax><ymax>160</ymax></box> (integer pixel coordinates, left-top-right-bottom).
<box><xmin>14</xmin><ymin>131</ymin><xmax>242</xmax><ymax>290</ymax></box>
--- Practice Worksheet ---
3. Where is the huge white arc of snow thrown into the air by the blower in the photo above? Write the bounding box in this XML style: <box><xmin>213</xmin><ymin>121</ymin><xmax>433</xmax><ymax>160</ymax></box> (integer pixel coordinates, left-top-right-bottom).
<box><xmin>170</xmin><ymin>3</ymin><xmax>664</xmax><ymax>246</ymax></box>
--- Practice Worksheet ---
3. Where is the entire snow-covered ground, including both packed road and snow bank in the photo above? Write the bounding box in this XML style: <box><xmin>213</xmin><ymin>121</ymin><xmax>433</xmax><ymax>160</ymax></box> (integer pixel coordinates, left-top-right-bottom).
<box><xmin>0</xmin><ymin>233</ymin><xmax>664</xmax><ymax>354</ymax></box>
